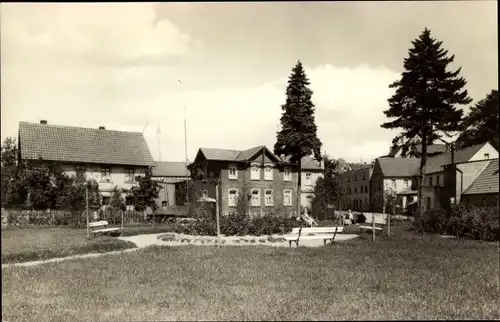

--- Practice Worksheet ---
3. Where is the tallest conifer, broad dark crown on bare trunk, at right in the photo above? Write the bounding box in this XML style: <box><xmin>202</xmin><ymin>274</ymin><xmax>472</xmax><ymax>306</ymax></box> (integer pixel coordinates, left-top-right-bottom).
<box><xmin>381</xmin><ymin>28</ymin><xmax>472</xmax><ymax>218</ymax></box>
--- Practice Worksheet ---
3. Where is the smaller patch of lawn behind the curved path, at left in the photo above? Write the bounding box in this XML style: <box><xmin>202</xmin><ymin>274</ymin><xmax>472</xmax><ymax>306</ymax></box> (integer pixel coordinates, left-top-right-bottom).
<box><xmin>2</xmin><ymin>225</ymin><xmax>171</xmax><ymax>264</ymax></box>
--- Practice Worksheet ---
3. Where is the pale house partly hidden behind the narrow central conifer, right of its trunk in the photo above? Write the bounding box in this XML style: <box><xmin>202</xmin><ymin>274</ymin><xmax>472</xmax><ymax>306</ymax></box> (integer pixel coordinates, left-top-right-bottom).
<box><xmin>282</xmin><ymin>157</ymin><xmax>324</xmax><ymax>210</ymax></box>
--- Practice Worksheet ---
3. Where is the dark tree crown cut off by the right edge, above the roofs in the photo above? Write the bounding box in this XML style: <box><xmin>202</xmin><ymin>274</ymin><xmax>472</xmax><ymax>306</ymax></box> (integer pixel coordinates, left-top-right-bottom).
<box><xmin>457</xmin><ymin>90</ymin><xmax>499</xmax><ymax>149</ymax></box>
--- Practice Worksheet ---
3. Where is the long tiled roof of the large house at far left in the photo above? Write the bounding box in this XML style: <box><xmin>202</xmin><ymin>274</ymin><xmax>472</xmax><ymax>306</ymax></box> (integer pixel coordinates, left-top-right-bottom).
<box><xmin>19</xmin><ymin>122</ymin><xmax>154</xmax><ymax>166</ymax></box>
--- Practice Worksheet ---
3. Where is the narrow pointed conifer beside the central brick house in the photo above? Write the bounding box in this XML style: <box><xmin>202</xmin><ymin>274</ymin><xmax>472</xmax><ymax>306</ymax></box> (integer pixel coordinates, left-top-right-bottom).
<box><xmin>274</xmin><ymin>61</ymin><xmax>322</xmax><ymax>216</ymax></box>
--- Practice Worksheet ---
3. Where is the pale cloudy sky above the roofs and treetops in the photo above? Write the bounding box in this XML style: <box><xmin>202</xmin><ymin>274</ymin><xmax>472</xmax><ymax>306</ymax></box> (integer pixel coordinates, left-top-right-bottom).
<box><xmin>0</xmin><ymin>1</ymin><xmax>498</xmax><ymax>162</ymax></box>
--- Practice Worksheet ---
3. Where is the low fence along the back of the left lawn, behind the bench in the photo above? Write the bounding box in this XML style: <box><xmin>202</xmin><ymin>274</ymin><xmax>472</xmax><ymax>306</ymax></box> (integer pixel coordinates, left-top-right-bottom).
<box><xmin>2</xmin><ymin>209</ymin><xmax>150</xmax><ymax>228</ymax></box>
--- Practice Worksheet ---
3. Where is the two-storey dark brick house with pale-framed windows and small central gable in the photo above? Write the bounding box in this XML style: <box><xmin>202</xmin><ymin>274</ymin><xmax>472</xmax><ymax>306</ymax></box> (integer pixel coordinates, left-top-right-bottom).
<box><xmin>188</xmin><ymin>146</ymin><xmax>298</xmax><ymax>215</ymax></box>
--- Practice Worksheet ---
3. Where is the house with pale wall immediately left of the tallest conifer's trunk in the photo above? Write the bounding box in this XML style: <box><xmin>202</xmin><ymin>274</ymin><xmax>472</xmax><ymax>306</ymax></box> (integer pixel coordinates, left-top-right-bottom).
<box><xmin>370</xmin><ymin>157</ymin><xmax>420</xmax><ymax>212</ymax></box>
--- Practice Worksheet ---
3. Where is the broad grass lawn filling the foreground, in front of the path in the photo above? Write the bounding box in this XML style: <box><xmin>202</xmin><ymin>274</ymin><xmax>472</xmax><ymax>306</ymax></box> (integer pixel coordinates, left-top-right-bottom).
<box><xmin>2</xmin><ymin>226</ymin><xmax>500</xmax><ymax>321</ymax></box>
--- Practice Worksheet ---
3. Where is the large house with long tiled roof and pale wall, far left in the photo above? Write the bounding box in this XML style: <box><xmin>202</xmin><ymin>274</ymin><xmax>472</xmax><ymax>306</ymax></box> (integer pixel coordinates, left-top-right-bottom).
<box><xmin>18</xmin><ymin>120</ymin><xmax>154</xmax><ymax>205</ymax></box>
